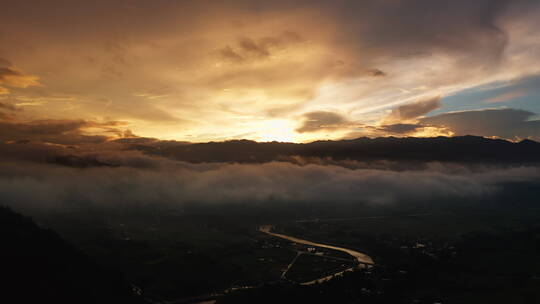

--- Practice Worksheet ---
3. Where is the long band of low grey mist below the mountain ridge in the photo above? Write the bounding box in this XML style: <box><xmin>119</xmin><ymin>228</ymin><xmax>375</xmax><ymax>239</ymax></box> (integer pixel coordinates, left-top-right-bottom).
<box><xmin>0</xmin><ymin>154</ymin><xmax>540</xmax><ymax>208</ymax></box>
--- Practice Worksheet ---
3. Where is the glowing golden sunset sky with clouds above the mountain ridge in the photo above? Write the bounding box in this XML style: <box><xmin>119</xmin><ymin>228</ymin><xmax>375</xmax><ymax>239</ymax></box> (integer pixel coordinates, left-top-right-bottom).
<box><xmin>0</xmin><ymin>0</ymin><xmax>540</xmax><ymax>145</ymax></box>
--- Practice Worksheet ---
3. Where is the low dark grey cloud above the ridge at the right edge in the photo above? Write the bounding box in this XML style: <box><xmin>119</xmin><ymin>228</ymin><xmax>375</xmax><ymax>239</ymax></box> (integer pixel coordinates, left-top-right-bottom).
<box><xmin>420</xmin><ymin>109</ymin><xmax>540</xmax><ymax>140</ymax></box>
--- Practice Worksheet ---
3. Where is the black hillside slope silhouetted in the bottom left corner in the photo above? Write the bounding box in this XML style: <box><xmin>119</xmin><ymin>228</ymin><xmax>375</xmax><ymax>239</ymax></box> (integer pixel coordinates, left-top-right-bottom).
<box><xmin>0</xmin><ymin>207</ymin><xmax>143</xmax><ymax>304</ymax></box>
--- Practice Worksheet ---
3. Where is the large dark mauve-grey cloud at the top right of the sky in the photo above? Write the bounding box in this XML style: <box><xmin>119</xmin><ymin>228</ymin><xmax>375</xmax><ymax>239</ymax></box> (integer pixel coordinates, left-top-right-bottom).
<box><xmin>322</xmin><ymin>0</ymin><xmax>535</xmax><ymax>63</ymax></box>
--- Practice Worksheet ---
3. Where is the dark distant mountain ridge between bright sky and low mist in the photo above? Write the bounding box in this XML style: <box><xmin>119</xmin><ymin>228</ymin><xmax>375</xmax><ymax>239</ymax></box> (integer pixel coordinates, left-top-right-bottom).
<box><xmin>124</xmin><ymin>136</ymin><xmax>540</xmax><ymax>163</ymax></box>
